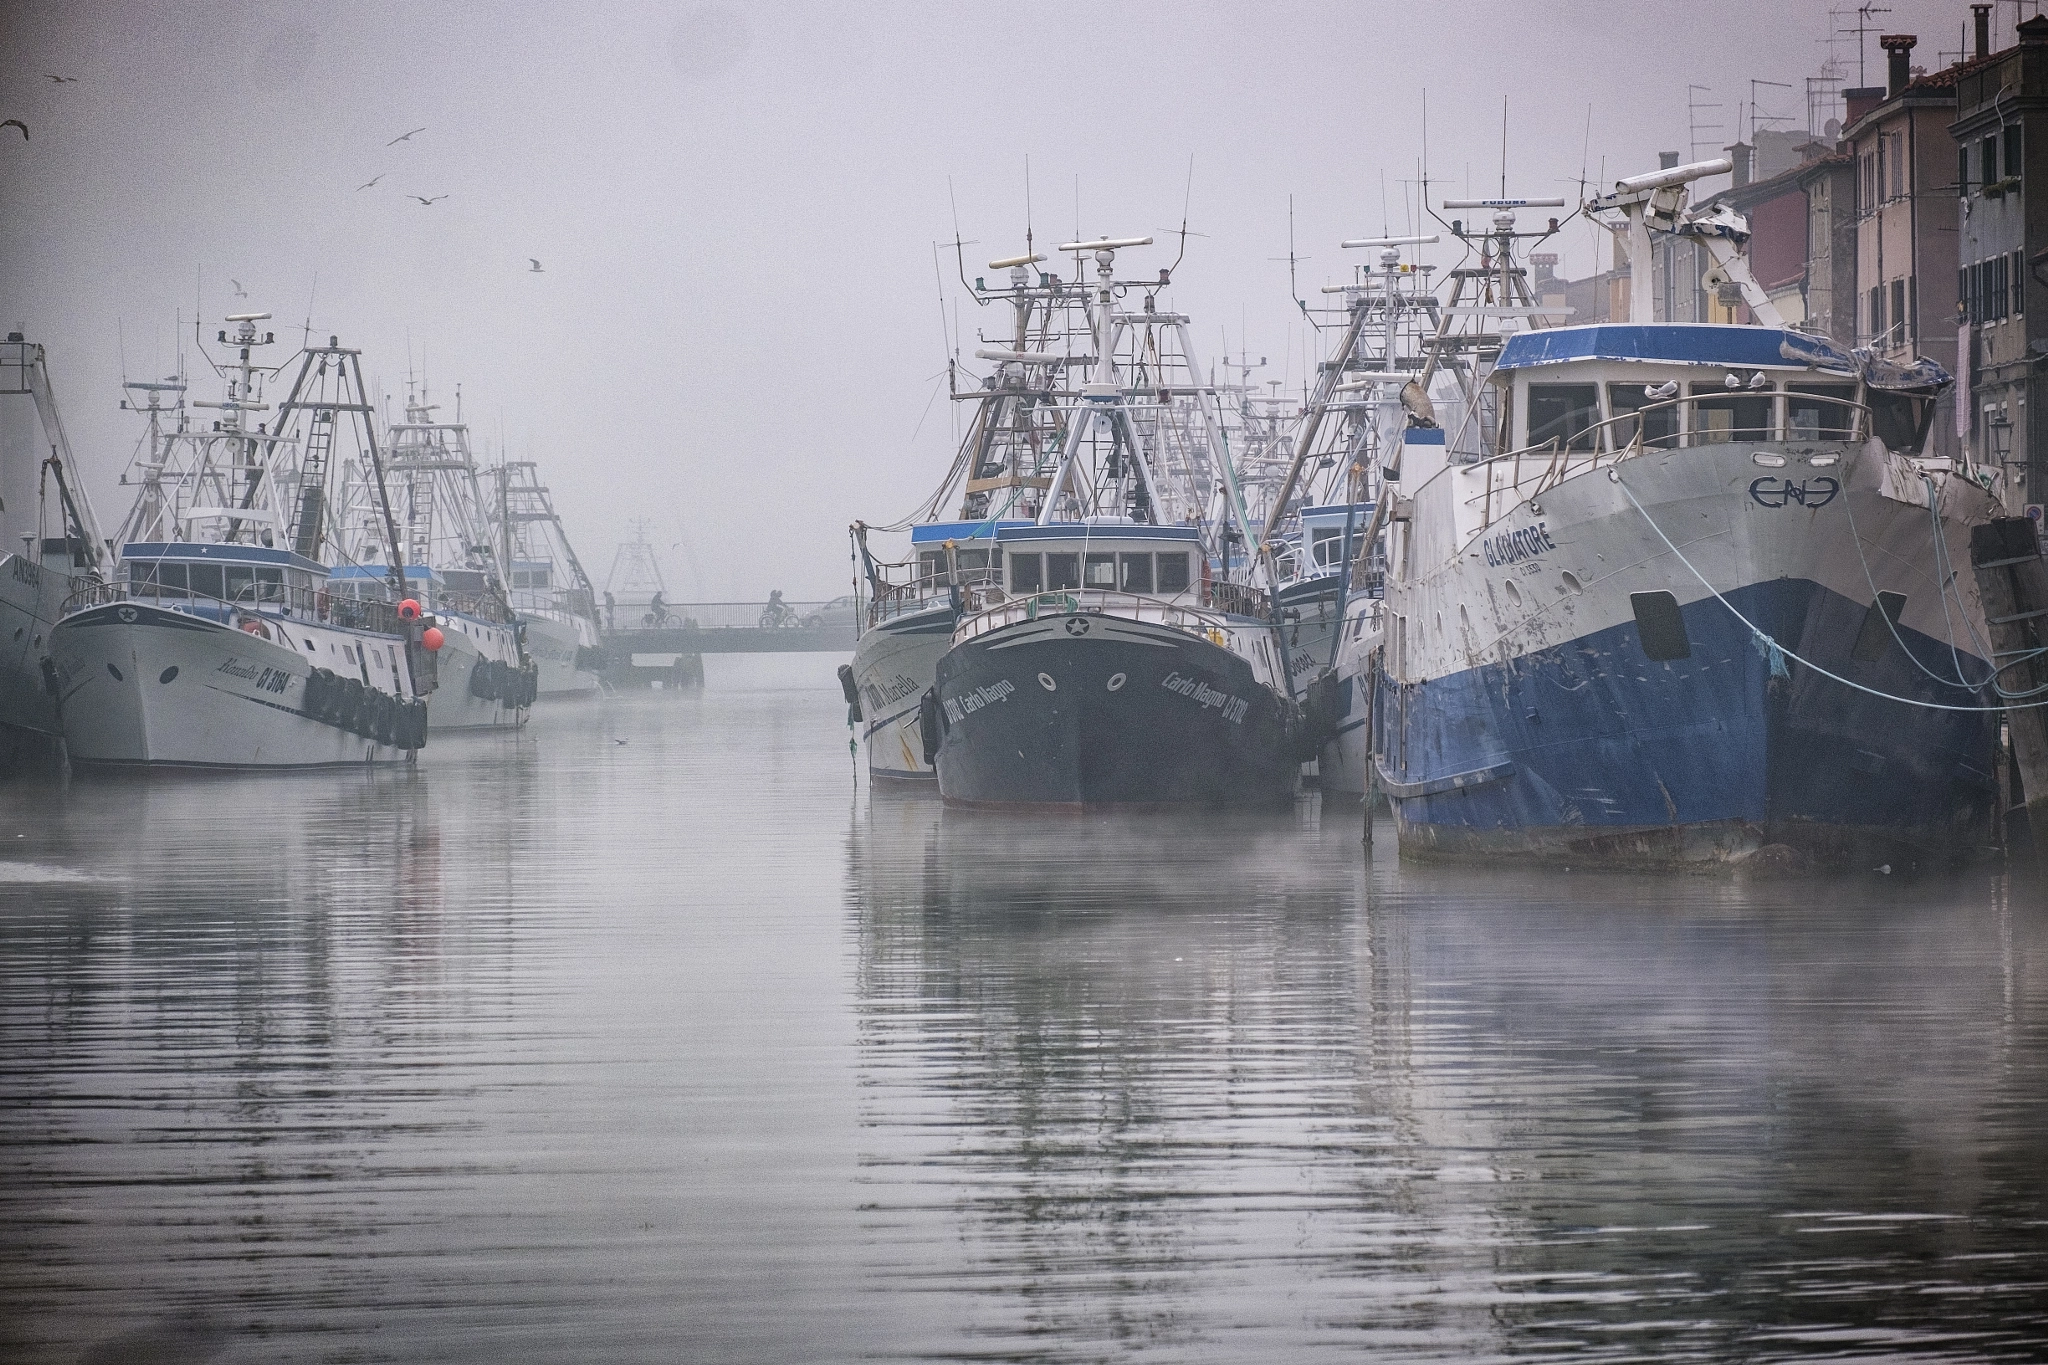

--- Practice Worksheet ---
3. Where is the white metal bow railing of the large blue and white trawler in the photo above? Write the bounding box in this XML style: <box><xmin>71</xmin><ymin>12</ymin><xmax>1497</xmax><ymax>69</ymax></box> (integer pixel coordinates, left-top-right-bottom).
<box><xmin>1460</xmin><ymin>389</ymin><xmax>1872</xmax><ymax>528</ymax></box>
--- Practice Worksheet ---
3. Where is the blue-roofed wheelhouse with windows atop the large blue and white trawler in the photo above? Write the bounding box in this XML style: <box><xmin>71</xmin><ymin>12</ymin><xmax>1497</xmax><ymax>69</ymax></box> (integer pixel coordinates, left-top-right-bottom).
<box><xmin>1493</xmin><ymin>323</ymin><xmax>1948</xmax><ymax>454</ymax></box>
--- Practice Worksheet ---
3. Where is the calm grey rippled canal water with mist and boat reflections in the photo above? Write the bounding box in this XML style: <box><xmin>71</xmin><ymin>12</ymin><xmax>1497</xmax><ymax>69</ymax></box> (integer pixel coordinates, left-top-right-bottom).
<box><xmin>0</xmin><ymin>657</ymin><xmax>2048</xmax><ymax>1363</ymax></box>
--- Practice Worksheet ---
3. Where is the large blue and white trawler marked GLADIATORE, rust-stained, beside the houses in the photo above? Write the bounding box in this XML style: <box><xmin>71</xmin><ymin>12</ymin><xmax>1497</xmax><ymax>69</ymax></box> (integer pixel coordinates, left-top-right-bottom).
<box><xmin>1374</xmin><ymin>164</ymin><xmax>1997</xmax><ymax>866</ymax></box>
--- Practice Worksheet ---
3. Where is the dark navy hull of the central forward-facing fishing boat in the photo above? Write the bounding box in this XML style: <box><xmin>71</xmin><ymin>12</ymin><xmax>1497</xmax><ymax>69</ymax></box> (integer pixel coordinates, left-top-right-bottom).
<box><xmin>936</xmin><ymin>614</ymin><xmax>1303</xmax><ymax>808</ymax></box>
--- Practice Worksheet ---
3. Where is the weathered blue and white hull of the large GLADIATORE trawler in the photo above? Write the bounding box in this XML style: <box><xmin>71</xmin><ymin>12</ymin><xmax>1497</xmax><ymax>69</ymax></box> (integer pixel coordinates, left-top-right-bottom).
<box><xmin>1376</xmin><ymin>435</ymin><xmax>1997</xmax><ymax>868</ymax></box>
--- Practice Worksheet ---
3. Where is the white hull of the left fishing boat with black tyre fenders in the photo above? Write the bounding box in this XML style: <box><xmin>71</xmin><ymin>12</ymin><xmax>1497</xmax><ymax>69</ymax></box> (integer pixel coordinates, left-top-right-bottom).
<box><xmin>51</xmin><ymin>602</ymin><xmax>410</xmax><ymax>769</ymax></box>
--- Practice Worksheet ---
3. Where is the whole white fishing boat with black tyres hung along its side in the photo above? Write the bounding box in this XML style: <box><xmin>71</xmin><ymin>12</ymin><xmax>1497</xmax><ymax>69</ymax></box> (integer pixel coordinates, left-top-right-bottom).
<box><xmin>51</xmin><ymin>313</ymin><xmax>432</xmax><ymax>767</ymax></box>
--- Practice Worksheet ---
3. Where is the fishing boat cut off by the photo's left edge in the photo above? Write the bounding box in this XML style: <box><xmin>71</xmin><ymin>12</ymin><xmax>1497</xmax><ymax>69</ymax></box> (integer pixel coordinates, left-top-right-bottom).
<box><xmin>0</xmin><ymin>332</ymin><xmax>107</xmax><ymax>755</ymax></box>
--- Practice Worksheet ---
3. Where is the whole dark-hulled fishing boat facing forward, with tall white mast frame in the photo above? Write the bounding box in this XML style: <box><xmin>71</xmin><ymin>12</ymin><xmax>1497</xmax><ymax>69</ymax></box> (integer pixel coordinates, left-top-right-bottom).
<box><xmin>924</xmin><ymin>237</ymin><xmax>1313</xmax><ymax>808</ymax></box>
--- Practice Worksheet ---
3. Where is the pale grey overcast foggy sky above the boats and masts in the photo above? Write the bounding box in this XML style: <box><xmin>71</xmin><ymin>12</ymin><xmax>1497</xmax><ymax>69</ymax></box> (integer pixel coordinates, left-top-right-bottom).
<box><xmin>0</xmin><ymin>0</ymin><xmax>1982</xmax><ymax>600</ymax></box>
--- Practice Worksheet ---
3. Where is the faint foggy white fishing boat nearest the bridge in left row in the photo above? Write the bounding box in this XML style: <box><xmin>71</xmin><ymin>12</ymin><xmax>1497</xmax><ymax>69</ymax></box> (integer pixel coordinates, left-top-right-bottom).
<box><xmin>492</xmin><ymin>460</ymin><xmax>604</xmax><ymax>698</ymax></box>
